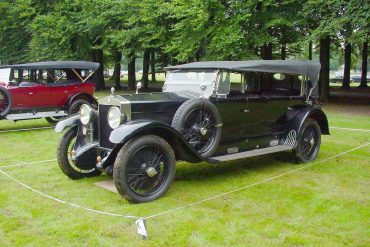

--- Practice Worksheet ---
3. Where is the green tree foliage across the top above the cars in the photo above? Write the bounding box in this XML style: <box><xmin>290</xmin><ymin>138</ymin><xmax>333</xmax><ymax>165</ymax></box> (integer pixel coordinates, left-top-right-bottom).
<box><xmin>0</xmin><ymin>0</ymin><xmax>370</xmax><ymax>90</ymax></box>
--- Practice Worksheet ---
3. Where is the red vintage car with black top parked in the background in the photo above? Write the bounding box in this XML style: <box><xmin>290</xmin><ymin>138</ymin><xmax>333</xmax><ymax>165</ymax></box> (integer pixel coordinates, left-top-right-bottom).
<box><xmin>0</xmin><ymin>61</ymin><xmax>99</xmax><ymax>122</ymax></box>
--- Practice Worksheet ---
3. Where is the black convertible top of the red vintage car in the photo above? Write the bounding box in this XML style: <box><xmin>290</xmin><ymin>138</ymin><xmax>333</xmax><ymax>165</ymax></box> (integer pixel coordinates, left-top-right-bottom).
<box><xmin>3</xmin><ymin>61</ymin><xmax>100</xmax><ymax>71</ymax></box>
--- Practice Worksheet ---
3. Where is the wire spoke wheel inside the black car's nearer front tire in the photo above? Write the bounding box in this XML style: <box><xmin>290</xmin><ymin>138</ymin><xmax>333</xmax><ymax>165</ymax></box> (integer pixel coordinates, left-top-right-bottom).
<box><xmin>126</xmin><ymin>146</ymin><xmax>169</xmax><ymax>196</ymax></box>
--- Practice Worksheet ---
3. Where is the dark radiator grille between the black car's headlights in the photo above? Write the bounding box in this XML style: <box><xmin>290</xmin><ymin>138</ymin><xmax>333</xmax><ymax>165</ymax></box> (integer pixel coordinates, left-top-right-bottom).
<box><xmin>99</xmin><ymin>105</ymin><xmax>114</xmax><ymax>149</ymax></box>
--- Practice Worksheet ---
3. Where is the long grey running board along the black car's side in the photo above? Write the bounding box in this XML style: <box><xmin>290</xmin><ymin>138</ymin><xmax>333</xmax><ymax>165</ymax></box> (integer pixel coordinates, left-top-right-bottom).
<box><xmin>208</xmin><ymin>145</ymin><xmax>292</xmax><ymax>163</ymax></box>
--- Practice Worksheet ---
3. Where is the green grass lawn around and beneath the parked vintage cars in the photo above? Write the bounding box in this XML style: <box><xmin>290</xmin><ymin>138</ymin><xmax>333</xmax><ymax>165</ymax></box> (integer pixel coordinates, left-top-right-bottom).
<box><xmin>0</xmin><ymin>96</ymin><xmax>370</xmax><ymax>246</ymax></box>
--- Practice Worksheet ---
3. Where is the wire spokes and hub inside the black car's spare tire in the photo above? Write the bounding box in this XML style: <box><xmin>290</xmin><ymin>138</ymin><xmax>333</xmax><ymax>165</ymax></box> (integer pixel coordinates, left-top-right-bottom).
<box><xmin>183</xmin><ymin>108</ymin><xmax>216</xmax><ymax>153</ymax></box>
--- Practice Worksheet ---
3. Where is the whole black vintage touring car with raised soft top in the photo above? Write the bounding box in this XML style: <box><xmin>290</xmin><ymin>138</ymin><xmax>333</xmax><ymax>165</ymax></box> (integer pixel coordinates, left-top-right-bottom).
<box><xmin>56</xmin><ymin>60</ymin><xmax>329</xmax><ymax>202</ymax></box>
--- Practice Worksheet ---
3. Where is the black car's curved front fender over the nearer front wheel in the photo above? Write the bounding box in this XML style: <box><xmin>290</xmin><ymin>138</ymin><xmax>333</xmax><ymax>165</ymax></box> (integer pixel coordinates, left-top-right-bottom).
<box><xmin>109</xmin><ymin>120</ymin><xmax>204</xmax><ymax>163</ymax></box>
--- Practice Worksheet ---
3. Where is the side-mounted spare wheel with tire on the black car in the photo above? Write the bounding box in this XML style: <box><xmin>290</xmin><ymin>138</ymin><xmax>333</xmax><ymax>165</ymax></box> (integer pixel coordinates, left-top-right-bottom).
<box><xmin>171</xmin><ymin>99</ymin><xmax>222</xmax><ymax>158</ymax></box>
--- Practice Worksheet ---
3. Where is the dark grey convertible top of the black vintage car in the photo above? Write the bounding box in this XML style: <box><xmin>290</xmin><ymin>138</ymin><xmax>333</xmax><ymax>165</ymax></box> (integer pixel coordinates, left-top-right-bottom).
<box><xmin>166</xmin><ymin>60</ymin><xmax>321</xmax><ymax>97</ymax></box>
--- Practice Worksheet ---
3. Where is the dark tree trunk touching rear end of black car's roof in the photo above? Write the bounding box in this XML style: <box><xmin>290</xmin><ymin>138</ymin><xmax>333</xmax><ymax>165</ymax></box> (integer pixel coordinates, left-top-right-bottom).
<box><xmin>319</xmin><ymin>36</ymin><xmax>330</xmax><ymax>102</ymax></box>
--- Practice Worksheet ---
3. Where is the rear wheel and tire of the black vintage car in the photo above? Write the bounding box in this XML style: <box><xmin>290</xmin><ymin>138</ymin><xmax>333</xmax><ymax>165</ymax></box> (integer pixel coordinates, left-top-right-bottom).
<box><xmin>293</xmin><ymin>118</ymin><xmax>321</xmax><ymax>163</ymax></box>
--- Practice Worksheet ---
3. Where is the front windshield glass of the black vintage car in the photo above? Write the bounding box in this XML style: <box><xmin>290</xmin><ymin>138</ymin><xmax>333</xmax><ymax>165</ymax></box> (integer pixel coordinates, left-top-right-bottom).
<box><xmin>163</xmin><ymin>70</ymin><xmax>217</xmax><ymax>97</ymax></box>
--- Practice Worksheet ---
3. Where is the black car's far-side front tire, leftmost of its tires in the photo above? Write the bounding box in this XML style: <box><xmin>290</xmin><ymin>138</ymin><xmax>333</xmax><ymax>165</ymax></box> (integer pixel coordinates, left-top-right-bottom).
<box><xmin>57</xmin><ymin>128</ymin><xmax>101</xmax><ymax>179</ymax></box>
